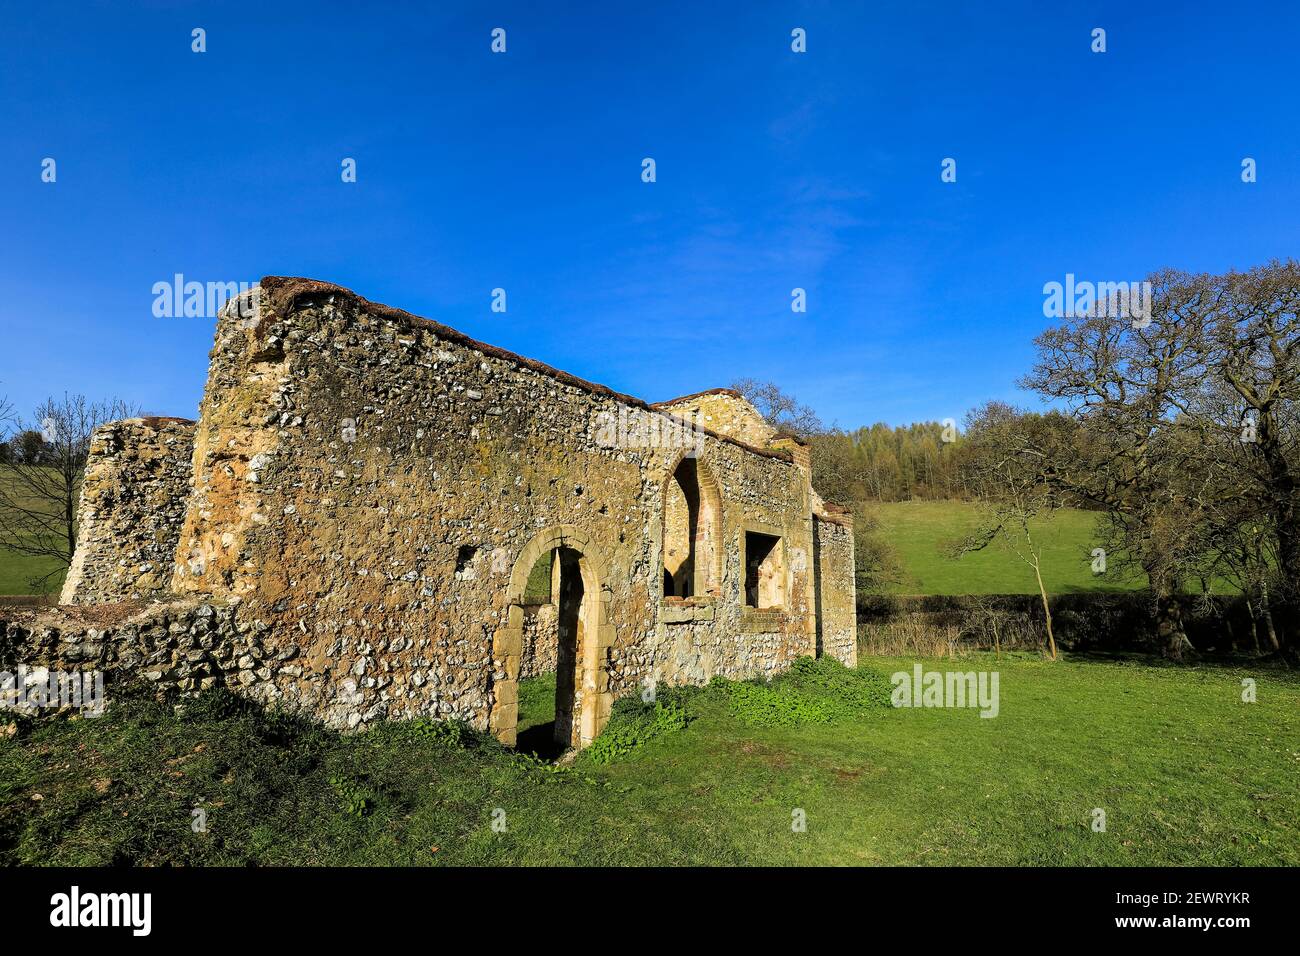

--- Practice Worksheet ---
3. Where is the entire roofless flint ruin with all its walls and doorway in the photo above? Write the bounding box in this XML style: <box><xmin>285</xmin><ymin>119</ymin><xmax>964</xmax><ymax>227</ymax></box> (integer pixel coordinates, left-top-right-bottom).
<box><xmin>0</xmin><ymin>277</ymin><xmax>857</xmax><ymax>747</ymax></box>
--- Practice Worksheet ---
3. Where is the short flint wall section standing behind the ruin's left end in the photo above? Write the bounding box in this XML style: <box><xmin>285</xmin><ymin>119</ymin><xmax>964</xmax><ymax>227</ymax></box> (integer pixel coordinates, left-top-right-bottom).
<box><xmin>60</xmin><ymin>418</ymin><xmax>194</xmax><ymax>604</ymax></box>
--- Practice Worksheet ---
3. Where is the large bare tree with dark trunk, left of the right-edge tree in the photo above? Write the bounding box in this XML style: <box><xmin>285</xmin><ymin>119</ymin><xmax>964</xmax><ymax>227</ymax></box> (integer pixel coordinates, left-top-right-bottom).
<box><xmin>1023</xmin><ymin>271</ymin><xmax>1226</xmax><ymax>659</ymax></box>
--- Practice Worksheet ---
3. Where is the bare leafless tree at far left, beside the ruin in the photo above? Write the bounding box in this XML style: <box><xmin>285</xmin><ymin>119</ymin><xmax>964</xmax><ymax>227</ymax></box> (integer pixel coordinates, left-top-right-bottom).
<box><xmin>0</xmin><ymin>394</ymin><xmax>134</xmax><ymax>585</ymax></box>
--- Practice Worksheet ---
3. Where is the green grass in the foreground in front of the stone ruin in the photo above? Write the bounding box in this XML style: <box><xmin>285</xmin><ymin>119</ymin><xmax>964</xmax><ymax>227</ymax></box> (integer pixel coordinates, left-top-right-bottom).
<box><xmin>0</xmin><ymin>656</ymin><xmax>1300</xmax><ymax>865</ymax></box>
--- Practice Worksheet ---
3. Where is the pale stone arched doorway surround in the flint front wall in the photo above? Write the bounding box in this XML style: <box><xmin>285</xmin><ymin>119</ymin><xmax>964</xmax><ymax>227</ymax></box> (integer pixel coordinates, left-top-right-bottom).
<box><xmin>489</xmin><ymin>524</ymin><xmax>614</xmax><ymax>747</ymax></box>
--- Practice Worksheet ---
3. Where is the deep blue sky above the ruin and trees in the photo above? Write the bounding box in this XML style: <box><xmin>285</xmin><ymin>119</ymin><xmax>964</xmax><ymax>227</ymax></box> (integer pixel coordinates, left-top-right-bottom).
<box><xmin>0</xmin><ymin>0</ymin><xmax>1300</xmax><ymax>427</ymax></box>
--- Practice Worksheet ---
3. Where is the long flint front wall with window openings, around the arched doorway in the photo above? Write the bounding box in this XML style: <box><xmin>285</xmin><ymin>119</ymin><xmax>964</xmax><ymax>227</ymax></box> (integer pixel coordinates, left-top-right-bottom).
<box><xmin>162</xmin><ymin>281</ymin><xmax>814</xmax><ymax>727</ymax></box>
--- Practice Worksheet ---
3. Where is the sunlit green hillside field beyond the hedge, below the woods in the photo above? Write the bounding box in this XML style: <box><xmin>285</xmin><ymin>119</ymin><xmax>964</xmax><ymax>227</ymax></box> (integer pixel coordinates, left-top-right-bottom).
<box><xmin>871</xmin><ymin>501</ymin><xmax>1147</xmax><ymax>594</ymax></box>
